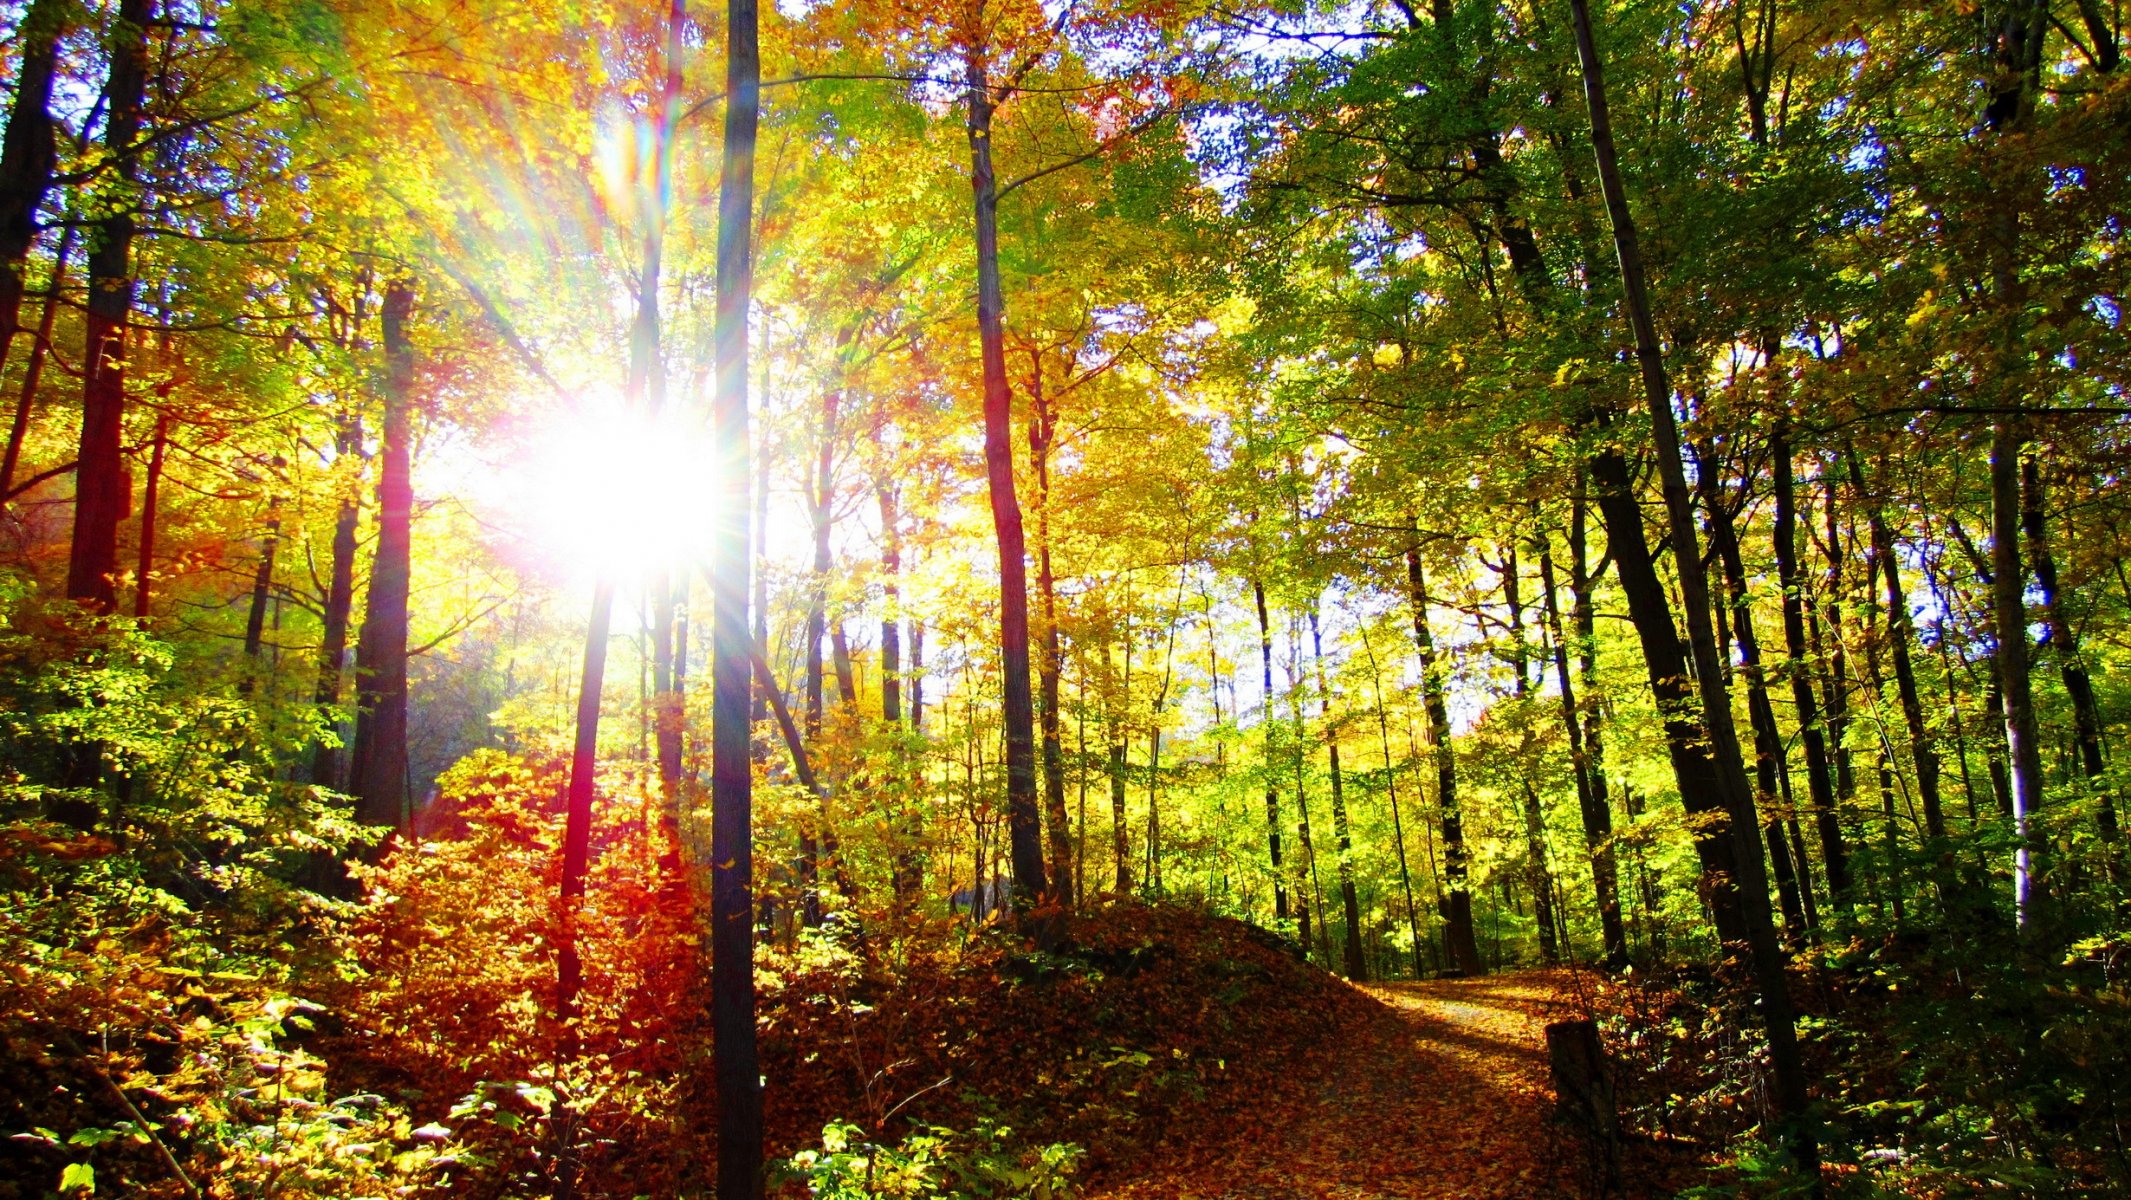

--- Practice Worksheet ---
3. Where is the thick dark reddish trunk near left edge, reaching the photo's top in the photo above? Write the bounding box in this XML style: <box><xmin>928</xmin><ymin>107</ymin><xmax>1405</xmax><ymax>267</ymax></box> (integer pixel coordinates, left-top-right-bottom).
<box><xmin>67</xmin><ymin>0</ymin><xmax>156</xmax><ymax>612</ymax></box>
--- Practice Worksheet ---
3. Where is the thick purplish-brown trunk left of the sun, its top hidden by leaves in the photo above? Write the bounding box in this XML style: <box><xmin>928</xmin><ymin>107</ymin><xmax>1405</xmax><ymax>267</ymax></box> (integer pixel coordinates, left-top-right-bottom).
<box><xmin>347</xmin><ymin>281</ymin><xmax>413</xmax><ymax>829</ymax></box>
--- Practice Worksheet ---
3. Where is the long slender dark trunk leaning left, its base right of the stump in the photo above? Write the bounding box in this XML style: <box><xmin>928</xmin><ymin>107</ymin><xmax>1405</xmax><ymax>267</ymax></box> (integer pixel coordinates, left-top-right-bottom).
<box><xmin>1571</xmin><ymin>0</ymin><xmax>1820</xmax><ymax>1177</ymax></box>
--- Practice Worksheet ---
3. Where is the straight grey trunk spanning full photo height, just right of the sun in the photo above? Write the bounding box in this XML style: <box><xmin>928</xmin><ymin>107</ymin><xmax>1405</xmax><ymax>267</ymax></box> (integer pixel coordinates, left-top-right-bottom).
<box><xmin>710</xmin><ymin>0</ymin><xmax>763</xmax><ymax>1200</ymax></box>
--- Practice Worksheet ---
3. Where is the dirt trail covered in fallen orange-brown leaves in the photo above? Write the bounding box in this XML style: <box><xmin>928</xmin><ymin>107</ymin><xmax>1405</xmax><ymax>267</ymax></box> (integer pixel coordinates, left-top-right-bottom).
<box><xmin>1089</xmin><ymin>972</ymin><xmax>1592</xmax><ymax>1200</ymax></box>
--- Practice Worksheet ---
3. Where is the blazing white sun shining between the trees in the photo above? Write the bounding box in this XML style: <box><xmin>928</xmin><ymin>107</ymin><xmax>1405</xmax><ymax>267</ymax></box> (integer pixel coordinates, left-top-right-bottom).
<box><xmin>507</xmin><ymin>399</ymin><xmax>718</xmax><ymax>580</ymax></box>
